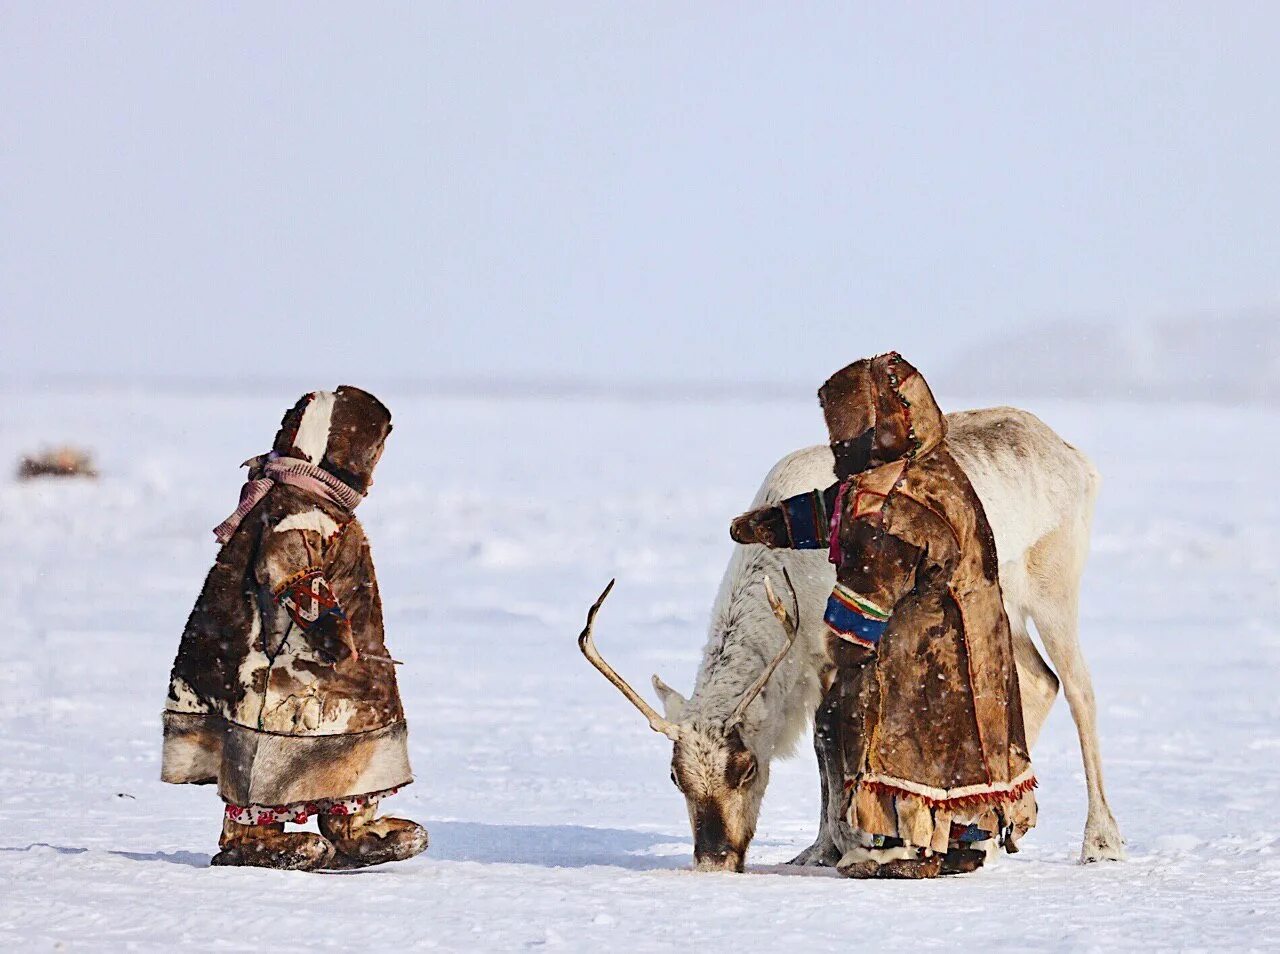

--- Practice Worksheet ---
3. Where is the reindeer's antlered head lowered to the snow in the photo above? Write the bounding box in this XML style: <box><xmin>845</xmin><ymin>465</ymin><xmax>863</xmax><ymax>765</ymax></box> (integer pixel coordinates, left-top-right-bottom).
<box><xmin>577</xmin><ymin>570</ymin><xmax>800</xmax><ymax>872</ymax></box>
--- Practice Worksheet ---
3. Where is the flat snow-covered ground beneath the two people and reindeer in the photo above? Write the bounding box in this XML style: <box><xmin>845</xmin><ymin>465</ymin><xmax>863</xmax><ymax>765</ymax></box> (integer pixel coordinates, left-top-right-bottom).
<box><xmin>0</xmin><ymin>382</ymin><xmax>1280</xmax><ymax>951</ymax></box>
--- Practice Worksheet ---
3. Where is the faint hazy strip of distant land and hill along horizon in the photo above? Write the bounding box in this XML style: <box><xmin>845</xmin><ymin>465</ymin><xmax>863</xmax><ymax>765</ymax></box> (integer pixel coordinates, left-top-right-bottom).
<box><xmin>0</xmin><ymin>307</ymin><xmax>1280</xmax><ymax>410</ymax></box>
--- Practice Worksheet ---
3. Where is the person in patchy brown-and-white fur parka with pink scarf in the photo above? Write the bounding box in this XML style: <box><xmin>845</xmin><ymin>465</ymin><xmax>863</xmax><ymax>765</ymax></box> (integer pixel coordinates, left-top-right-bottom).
<box><xmin>161</xmin><ymin>387</ymin><xmax>426</xmax><ymax>869</ymax></box>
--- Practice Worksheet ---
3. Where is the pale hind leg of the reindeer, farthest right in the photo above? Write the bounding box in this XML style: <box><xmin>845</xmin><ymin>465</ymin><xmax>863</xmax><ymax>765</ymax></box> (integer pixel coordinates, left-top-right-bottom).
<box><xmin>1030</xmin><ymin>529</ymin><xmax>1125</xmax><ymax>864</ymax></box>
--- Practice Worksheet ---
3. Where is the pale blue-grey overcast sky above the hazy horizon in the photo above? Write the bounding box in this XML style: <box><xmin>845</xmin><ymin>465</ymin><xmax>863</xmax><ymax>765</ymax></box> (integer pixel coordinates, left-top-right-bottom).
<box><xmin>0</xmin><ymin>0</ymin><xmax>1280</xmax><ymax>383</ymax></box>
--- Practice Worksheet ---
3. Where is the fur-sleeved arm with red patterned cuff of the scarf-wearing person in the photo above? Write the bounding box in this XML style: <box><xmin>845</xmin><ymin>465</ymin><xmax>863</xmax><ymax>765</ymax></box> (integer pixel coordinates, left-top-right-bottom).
<box><xmin>257</xmin><ymin>519</ymin><xmax>360</xmax><ymax>665</ymax></box>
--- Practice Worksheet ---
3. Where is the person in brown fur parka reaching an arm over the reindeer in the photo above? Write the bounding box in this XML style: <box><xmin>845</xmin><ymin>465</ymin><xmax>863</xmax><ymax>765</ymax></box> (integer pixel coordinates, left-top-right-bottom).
<box><xmin>730</xmin><ymin>353</ymin><xmax>1036</xmax><ymax>877</ymax></box>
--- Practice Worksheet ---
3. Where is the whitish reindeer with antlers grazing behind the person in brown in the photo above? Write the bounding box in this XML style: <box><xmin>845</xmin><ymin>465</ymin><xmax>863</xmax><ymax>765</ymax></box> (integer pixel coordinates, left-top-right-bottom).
<box><xmin>579</xmin><ymin>407</ymin><xmax>1125</xmax><ymax>872</ymax></box>
